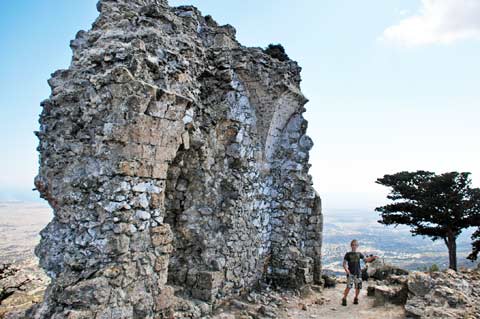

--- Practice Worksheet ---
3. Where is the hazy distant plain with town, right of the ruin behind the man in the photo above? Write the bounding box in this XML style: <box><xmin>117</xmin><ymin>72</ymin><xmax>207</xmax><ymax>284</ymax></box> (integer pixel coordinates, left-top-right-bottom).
<box><xmin>322</xmin><ymin>210</ymin><xmax>478</xmax><ymax>275</ymax></box>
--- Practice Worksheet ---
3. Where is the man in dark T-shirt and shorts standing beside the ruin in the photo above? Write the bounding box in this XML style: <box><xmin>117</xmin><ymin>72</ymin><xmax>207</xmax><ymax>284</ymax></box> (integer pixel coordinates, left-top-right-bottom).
<box><xmin>342</xmin><ymin>239</ymin><xmax>377</xmax><ymax>306</ymax></box>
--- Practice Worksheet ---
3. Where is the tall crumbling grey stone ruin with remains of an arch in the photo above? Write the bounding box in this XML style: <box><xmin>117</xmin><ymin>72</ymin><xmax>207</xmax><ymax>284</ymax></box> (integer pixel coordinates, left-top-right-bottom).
<box><xmin>30</xmin><ymin>0</ymin><xmax>322</xmax><ymax>319</ymax></box>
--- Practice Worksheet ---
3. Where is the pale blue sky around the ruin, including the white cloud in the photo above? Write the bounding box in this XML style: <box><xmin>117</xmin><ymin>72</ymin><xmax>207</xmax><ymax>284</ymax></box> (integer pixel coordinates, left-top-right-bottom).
<box><xmin>0</xmin><ymin>0</ymin><xmax>480</xmax><ymax>210</ymax></box>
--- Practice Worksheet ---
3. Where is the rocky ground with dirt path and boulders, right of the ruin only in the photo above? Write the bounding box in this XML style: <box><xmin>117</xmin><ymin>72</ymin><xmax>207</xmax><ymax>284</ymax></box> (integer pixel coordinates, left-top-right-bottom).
<box><xmin>207</xmin><ymin>262</ymin><xmax>480</xmax><ymax>319</ymax></box>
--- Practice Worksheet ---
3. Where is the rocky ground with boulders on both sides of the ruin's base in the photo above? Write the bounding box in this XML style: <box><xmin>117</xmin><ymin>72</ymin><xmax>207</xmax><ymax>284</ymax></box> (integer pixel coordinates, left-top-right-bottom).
<box><xmin>4</xmin><ymin>268</ymin><xmax>480</xmax><ymax>319</ymax></box>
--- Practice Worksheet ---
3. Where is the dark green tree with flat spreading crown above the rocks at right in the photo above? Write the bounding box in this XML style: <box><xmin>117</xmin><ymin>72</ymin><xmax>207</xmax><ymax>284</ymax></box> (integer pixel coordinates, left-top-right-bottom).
<box><xmin>375</xmin><ymin>171</ymin><xmax>480</xmax><ymax>270</ymax></box>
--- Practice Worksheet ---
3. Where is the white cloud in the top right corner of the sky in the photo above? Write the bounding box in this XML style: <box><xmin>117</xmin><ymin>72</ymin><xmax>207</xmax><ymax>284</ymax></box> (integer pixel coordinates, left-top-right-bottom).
<box><xmin>381</xmin><ymin>0</ymin><xmax>480</xmax><ymax>47</ymax></box>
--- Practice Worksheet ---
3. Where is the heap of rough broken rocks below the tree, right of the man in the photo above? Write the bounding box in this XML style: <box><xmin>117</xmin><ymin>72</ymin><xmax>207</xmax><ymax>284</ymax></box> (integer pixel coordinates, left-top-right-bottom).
<box><xmin>367</xmin><ymin>264</ymin><xmax>480</xmax><ymax>319</ymax></box>
